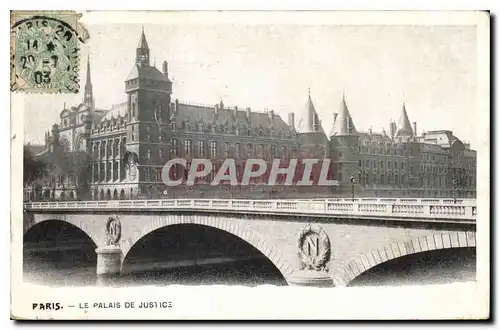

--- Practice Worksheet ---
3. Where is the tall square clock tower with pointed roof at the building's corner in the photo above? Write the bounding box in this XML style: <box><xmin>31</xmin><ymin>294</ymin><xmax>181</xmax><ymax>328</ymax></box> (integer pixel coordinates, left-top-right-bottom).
<box><xmin>123</xmin><ymin>28</ymin><xmax>172</xmax><ymax>197</ymax></box>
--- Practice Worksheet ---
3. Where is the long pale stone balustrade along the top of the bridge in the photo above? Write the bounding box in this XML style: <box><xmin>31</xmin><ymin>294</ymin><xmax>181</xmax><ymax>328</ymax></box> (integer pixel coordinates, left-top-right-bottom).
<box><xmin>24</xmin><ymin>199</ymin><xmax>477</xmax><ymax>221</ymax></box>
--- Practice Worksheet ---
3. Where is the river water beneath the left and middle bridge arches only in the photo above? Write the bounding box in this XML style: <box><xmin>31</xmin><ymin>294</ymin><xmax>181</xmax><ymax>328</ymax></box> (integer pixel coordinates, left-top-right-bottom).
<box><xmin>24</xmin><ymin>255</ymin><xmax>286</xmax><ymax>287</ymax></box>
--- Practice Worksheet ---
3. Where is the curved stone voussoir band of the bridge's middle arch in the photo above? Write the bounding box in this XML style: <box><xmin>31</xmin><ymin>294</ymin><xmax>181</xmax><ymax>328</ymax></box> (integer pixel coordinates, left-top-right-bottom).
<box><xmin>121</xmin><ymin>215</ymin><xmax>293</xmax><ymax>280</ymax></box>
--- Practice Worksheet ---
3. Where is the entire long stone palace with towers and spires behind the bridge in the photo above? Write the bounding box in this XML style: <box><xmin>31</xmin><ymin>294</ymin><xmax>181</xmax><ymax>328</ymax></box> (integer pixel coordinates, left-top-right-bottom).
<box><xmin>27</xmin><ymin>31</ymin><xmax>476</xmax><ymax>199</ymax></box>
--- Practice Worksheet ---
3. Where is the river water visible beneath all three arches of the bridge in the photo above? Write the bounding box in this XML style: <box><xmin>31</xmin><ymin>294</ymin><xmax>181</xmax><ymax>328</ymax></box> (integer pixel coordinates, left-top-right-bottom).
<box><xmin>24</xmin><ymin>249</ymin><xmax>476</xmax><ymax>287</ymax></box>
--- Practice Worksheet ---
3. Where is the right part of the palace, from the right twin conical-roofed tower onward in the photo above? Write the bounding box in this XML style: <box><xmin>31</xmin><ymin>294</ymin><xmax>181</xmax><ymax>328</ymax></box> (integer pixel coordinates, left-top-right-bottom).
<box><xmin>330</xmin><ymin>99</ymin><xmax>476</xmax><ymax>198</ymax></box>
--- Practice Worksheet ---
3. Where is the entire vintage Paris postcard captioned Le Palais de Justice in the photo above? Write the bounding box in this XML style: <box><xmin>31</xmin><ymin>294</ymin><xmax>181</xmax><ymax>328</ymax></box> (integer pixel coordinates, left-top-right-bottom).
<box><xmin>10</xmin><ymin>11</ymin><xmax>490</xmax><ymax>320</ymax></box>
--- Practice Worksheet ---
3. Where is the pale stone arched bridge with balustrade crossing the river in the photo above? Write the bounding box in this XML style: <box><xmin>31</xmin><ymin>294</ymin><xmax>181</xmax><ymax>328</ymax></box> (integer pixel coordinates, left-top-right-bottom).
<box><xmin>23</xmin><ymin>199</ymin><xmax>476</xmax><ymax>286</ymax></box>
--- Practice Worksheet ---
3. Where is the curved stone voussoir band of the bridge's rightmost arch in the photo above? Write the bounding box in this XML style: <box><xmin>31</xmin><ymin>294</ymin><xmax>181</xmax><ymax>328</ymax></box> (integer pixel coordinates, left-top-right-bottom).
<box><xmin>333</xmin><ymin>231</ymin><xmax>476</xmax><ymax>286</ymax></box>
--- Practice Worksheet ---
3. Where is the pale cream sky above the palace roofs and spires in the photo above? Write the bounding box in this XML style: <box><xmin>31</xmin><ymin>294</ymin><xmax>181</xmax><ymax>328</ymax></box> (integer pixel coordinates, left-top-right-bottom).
<box><xmin>24</xmin><ymin>16</ymin><xmax>478</xmax><ymax>148</ymax></box>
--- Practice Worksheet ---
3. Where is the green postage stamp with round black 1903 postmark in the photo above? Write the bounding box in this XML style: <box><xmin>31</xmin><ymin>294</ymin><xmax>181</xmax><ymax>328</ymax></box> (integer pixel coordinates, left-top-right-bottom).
<box><xmin>11</xmin><ymin>11</ymin><xmax>87</xmax><ymax>93</ymax></box>
